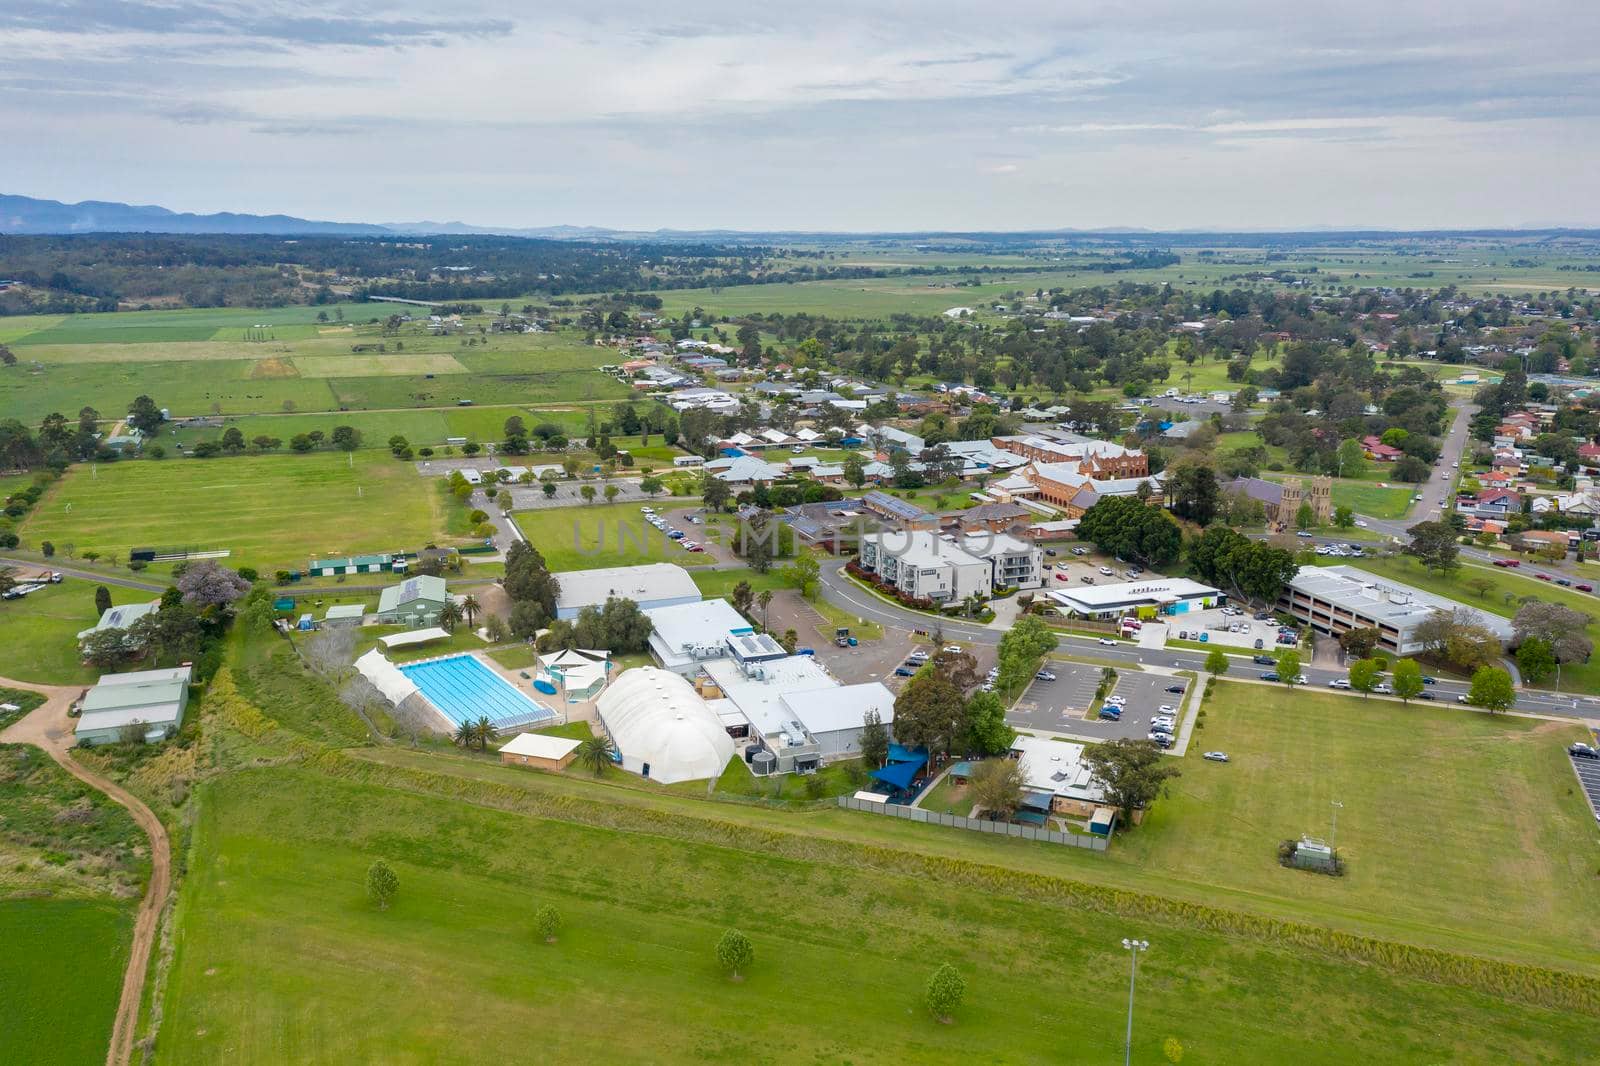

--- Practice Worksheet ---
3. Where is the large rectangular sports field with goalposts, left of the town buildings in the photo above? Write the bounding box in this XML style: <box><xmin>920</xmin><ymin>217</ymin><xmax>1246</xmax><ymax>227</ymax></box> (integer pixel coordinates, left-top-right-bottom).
<box><xmin>21</xmin><ymin>451</ymin><xmax>443</xmax><ymax>570</ymax></box>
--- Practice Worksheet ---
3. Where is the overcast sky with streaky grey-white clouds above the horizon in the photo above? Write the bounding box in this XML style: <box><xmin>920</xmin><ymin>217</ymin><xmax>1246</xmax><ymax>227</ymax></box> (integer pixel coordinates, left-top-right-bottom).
<box><xmin>0</xmin><ymin>0</ymin><xmax>1600</xmax><ymax>230</ymax></box>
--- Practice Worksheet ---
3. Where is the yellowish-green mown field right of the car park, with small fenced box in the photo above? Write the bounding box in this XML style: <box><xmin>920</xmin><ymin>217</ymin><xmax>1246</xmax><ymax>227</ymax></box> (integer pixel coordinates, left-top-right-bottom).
<box><xmin>1109</xmin><ymin>682</ymin><xmax>1600</xmax><ymax>965</ymax></box>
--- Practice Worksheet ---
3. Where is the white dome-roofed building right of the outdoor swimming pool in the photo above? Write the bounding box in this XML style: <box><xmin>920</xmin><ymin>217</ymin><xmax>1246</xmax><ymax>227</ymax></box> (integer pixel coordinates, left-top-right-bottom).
<box><xmin>597</xmin><ymin>666</ymin><xmax>733</xmax><ymax>784</ymax></box>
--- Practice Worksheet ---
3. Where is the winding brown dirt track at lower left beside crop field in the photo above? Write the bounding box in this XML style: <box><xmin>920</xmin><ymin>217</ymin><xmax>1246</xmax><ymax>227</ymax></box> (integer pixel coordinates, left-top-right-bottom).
<box><xmin>0</xmin><ymin>677</ymin><xmax>173</xmax><ymax>1066</ymax></box>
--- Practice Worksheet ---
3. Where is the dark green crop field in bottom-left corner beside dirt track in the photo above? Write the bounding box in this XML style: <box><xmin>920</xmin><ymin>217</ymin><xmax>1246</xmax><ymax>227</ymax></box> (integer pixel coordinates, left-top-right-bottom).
<box><xmin>0</xmin><ymin>900</ymin><xmax>133</xmax><ymax>1066</ymax></box>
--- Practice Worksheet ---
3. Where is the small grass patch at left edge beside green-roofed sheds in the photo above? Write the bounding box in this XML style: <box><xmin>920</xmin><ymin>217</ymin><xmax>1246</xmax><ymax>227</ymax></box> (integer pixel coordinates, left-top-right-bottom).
<box><xmin>0</xmin><ymin>578</ymin><xmax>158</xmax><ymax>685</ymax></box>
